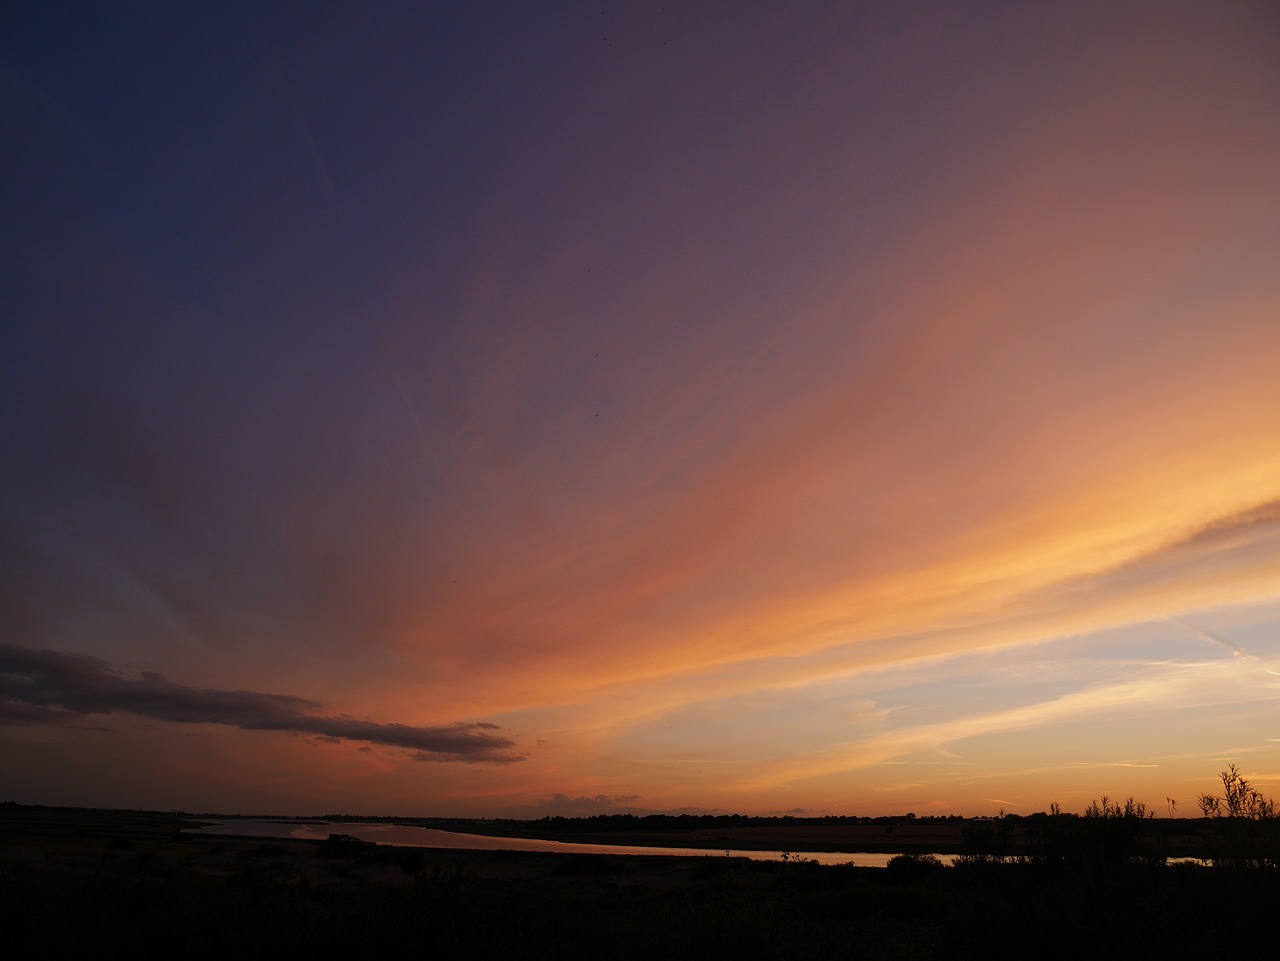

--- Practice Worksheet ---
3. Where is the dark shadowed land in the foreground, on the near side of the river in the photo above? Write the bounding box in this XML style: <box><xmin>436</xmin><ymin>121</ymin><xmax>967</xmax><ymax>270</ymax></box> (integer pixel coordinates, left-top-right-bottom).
<box><xmin>0</xmin><ymin>806</ymin><xmax>1280</xmax><ymax>961</ymax></box>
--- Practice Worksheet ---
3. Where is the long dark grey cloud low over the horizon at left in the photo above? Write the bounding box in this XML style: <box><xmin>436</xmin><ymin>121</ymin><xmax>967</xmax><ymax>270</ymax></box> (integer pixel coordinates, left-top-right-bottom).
<box><xmin>0</xmin><ymin>645</ymin><xmax>524</xmax><ymax>764</ymax></box>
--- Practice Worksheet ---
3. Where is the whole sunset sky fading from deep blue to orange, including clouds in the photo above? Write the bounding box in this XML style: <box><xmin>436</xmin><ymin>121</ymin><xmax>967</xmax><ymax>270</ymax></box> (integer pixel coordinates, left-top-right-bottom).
<box><xmin>0</xmin><ymin>0</ymin><xmax>1280</xmax><ymax>816</ymax></box>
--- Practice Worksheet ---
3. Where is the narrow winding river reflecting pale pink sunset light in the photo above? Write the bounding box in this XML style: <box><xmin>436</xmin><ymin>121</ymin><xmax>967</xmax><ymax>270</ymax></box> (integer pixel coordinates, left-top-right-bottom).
<box><xmin>187</xmin><ymin>819</ymin><xmax>952</xmax><ymax>868</ymax></box>
